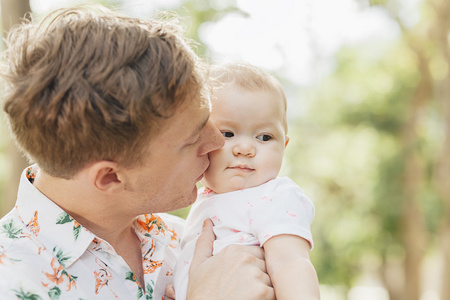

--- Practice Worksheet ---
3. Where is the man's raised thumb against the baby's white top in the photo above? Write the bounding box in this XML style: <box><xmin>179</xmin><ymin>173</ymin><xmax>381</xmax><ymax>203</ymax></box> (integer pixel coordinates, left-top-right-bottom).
<box><xmin>190</xmin><ymin>219</ymin><xmax>216</xmax><ymax>272</ymax></box>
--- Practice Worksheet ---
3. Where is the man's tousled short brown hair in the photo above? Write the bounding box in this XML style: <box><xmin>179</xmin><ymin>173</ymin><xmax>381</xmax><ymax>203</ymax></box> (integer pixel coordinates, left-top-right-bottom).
<box><xmin>1</xmin><ymin>5</ymin><xmax>204</xmax><ymax>179</ymax></box>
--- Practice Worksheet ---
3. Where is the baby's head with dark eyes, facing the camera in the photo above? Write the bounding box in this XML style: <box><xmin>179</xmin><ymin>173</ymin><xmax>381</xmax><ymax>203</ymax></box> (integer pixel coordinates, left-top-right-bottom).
<box><xmin>202</xmin><ymin>63</ymin><xmax>289</xmax><ymax>193</ymax></box>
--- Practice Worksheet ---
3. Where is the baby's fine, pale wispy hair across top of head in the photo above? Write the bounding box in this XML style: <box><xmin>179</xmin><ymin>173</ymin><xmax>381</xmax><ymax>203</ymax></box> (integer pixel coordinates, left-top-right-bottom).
<box><xmin>209</xmin><ymin>62</ymin><xmax>287</xmax><ymax>132</ymax></box>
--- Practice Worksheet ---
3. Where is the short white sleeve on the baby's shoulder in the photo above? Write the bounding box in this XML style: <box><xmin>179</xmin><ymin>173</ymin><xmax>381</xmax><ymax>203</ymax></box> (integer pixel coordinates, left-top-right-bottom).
<box><xmin>250</xmin><ymin>177</ymin><xmax>314</xmax><ymax>249</ymax></box>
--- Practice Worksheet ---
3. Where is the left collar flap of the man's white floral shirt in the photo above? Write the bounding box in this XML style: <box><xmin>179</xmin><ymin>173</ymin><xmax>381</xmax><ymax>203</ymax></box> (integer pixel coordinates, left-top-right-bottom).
<box><xmin>16</xmin><ymin>165</ymin><xmax>96</xmax><ymax>268</ymax></box>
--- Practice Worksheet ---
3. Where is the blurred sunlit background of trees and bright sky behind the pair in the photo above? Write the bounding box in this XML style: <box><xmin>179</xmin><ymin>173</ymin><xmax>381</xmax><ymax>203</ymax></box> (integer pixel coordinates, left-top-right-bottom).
<box><xmin>0</xmin><ymin>0</ymin><xmax>450</xmax><ymax>300</ymax></box>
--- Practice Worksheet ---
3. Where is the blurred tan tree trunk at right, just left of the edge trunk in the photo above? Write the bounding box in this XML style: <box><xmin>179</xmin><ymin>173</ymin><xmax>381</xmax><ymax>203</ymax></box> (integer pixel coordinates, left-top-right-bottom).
<box><xmin>401</xmin><ymin>39</ymin><xmax>433</xmax><ymax>300</ymax></box>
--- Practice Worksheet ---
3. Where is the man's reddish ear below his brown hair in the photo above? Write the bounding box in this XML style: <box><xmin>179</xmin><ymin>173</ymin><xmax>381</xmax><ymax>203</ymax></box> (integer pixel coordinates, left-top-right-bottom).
<box><xmin>88</xmin><ymin>160</ymin><xmax>123</xmax><ymax>192</ymax></box>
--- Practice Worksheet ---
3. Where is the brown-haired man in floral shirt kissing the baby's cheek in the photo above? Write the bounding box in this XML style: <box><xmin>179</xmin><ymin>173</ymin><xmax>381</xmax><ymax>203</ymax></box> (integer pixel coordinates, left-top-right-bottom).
<box><xmin>0</xmin><ymin>6</ymin><xmax>274</xmax><ymax>299</ymax></box>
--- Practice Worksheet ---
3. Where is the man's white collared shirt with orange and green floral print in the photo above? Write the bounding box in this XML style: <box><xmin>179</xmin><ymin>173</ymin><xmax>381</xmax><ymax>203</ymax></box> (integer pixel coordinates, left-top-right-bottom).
<box><xmin>0</xmin><ymin>167</ymin><xmax>184</xmax><ymax>300</ymax></box>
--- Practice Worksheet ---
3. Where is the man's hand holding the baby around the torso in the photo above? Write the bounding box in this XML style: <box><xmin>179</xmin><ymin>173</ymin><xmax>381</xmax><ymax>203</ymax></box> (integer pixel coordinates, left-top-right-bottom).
<box><xmin>187</xmin><ymin>220</ymin><xmax>275</xmax><ymax>300</ymax></box>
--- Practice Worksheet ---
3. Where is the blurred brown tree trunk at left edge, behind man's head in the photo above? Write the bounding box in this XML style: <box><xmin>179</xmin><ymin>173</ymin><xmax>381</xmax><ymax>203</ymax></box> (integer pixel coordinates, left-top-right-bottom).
<box><xmin>0</xmin><ymin>0</ymin><xmax>31</xmax><ymax>217</ymax></box>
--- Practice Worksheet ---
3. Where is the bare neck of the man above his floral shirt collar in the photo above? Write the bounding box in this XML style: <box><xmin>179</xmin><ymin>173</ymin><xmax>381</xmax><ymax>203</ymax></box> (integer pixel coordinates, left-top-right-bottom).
<box><xmin>33</xmin><ymin>170</ymin><xmax>143</xmax><ymax>286</ymax></box>
